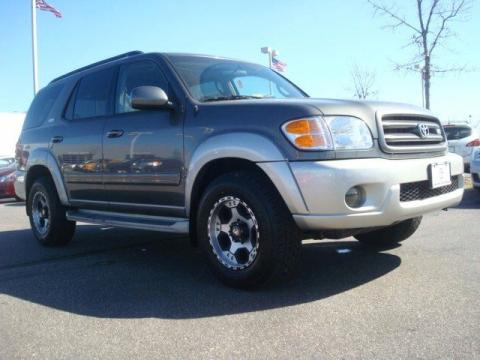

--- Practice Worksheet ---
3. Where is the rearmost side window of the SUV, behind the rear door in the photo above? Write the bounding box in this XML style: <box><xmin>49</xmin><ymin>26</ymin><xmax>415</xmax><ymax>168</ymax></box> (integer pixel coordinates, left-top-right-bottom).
<box><xmin>23</xmin><ymin>85</ymin><xmax>63</xmax><ymax>129</ymax></box>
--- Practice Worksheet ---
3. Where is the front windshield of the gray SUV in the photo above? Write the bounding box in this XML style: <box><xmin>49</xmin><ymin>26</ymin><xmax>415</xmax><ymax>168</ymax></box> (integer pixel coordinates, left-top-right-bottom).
<box><xmin>168</xmin><ymin>55</ymin><xmax>307</xmax><ymax>102</ymax></box>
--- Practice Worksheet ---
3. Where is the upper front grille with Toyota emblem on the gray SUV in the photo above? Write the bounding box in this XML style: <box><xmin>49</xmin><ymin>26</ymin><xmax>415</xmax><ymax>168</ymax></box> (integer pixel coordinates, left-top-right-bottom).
<box><xmin>380</xmin><ymin>115</ymin><xmax>446</xmax><ymax>153</ymax></box>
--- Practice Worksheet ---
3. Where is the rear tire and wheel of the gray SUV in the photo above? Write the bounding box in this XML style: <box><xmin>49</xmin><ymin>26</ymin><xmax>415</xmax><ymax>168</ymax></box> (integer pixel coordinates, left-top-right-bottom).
<box><xmin>27</xmin><ymin>177</ymin><xmax>76</xmax><ymax>246</ymax></box>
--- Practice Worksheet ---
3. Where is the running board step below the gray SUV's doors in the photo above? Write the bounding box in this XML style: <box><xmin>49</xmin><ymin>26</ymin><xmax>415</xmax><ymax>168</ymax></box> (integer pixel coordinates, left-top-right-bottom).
<box><xmin>67</xmin><ymin>210</ymin><xmax>189</xmax><ymax>234</ymax></box>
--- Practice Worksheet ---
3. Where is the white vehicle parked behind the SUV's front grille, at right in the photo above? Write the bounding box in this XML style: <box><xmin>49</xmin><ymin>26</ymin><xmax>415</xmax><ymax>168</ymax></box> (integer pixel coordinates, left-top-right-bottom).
<box><xmin>443</xmin><ymin>124</ymin><xmax>480</xmax><ymax>172</ymax></box>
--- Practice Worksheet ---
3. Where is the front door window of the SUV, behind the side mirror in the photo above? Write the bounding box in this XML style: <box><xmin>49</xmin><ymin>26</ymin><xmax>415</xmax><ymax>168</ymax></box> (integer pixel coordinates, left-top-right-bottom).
<box><xmin>115</xmin><ymin>61</ymin><xmax>168</xmax><ymax>114</ymax></box>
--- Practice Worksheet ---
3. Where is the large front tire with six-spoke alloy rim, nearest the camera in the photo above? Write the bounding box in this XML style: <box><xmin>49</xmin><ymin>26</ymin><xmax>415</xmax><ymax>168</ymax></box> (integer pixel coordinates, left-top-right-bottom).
<box><xmin>196</xmin><ymin>171</ymin><xmax>301</xmax><ymax>288</ymax></box>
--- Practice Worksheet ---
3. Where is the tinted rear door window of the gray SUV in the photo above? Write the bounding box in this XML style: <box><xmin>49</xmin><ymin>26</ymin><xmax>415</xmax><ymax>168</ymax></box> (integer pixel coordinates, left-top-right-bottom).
<box><xmin>73</xmin><ymin>68</ymin><xmax>114</xmax><ymax>119</ymax></box>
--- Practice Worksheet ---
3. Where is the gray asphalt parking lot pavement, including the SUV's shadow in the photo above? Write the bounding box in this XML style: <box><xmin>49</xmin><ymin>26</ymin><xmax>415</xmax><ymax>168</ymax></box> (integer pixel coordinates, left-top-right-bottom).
<box><xmin>0</xmin><ymin>186</ymin><xmax>480</xmax><ymax>359</ymax></box>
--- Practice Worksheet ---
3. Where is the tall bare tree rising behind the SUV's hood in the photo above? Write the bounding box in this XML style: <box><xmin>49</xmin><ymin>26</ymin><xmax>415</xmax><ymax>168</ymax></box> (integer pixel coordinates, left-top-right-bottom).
<box><xmin>368</xmin><ymin>0</ymin><xmax>471</xmax><ymax>109</ymax></box>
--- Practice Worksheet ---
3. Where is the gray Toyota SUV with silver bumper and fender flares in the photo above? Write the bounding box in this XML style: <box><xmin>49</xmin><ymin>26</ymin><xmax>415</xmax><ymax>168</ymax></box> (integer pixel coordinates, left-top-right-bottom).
<box><xmin>16</xmin><ymin>52</ymin><xmax>463</xmax><ymax>287</ymax></box>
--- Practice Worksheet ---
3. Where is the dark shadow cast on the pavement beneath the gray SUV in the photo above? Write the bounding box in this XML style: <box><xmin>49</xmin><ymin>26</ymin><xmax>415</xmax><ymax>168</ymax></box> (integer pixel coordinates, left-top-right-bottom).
<box><xmin>0</xmin><ymin>226</ymin><xmax>401</xmax><ymax>319</ymax></box>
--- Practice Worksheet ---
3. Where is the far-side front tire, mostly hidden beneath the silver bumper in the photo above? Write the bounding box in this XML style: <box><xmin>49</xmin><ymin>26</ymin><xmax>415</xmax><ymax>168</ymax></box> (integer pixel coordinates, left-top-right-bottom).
<box><xmin>355</xmin><ymin>216</ymin><xmax>422</xmax><ymax>246</ymax></box>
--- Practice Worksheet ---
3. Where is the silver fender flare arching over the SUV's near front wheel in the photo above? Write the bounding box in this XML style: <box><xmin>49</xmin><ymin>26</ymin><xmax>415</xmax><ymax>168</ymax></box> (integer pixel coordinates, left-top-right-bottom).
<box><xmin>185</xmin><ymin>133</ymin><xmax>306</xmax><ymax>214</ymax></box>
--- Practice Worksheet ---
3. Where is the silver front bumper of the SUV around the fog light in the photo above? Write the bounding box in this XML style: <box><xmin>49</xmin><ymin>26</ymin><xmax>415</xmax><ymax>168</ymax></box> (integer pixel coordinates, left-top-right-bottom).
<box><xmin>290</xmin><ymin>154</ymin><xmax>464</xmax><ymax>230</ymax></box>
